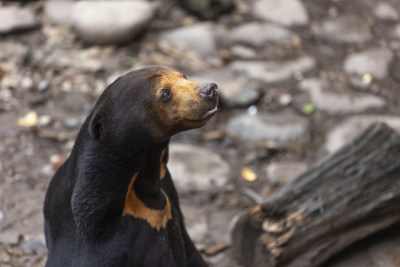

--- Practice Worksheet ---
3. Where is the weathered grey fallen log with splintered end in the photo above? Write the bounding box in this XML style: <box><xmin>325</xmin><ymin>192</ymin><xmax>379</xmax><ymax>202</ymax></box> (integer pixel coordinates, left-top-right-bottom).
<box><xmin>232</xmin><ymin>124</ymin><xmax>400</xmax><ymax>267</ymax></box>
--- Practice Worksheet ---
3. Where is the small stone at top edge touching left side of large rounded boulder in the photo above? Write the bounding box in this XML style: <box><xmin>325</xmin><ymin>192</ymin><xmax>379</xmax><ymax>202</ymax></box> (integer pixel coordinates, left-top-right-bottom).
<box><xmin>43</xmin><ymin>0</ymin><xmax>75</xmax><ymax>25</ymax></box>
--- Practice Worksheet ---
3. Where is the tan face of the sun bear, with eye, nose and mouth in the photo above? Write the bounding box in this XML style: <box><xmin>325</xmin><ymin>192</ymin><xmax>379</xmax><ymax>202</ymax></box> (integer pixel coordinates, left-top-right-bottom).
<box><xmin>148</xmin><ymin>69</ymin><xmax>218</xmax><ymax>140</ymax></box>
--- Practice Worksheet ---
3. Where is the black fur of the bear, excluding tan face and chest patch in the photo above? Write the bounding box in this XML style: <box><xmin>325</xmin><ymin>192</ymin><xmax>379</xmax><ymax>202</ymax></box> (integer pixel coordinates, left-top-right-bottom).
<box><xmin>44</xmin><ymin>68</ymin><xmax>207</xmax><ymax>267</ymax></box>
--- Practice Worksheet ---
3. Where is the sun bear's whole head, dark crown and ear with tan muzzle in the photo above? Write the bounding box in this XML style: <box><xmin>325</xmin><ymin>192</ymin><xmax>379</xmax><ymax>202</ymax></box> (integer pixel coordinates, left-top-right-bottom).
<box><xmin>89</xmin><ymin>67</ymin><xmax>218</xmax><ymax>150</ymax></box>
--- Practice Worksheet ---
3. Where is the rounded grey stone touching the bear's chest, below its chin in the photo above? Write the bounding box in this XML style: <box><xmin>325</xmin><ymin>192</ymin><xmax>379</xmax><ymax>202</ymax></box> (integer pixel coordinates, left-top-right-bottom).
<box><xmin>168</xmin><ymin>143</ymin><xmax>230</xmax><ymax>194</ymax></box>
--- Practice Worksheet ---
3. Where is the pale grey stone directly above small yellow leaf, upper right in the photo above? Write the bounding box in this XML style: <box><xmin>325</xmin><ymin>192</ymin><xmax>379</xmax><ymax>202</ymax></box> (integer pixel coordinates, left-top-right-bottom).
<box><xmin>344</xmin><ymin>48</ymin><xmax>393</xmax><ymax>80</ymax></box>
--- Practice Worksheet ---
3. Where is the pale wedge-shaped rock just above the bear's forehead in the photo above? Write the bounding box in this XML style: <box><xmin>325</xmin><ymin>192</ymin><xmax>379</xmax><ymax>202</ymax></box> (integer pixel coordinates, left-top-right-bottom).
<box><xmin>158</xmin><ymin>22</ymin><xmax>219</xmax><ymax>57</ymax></box>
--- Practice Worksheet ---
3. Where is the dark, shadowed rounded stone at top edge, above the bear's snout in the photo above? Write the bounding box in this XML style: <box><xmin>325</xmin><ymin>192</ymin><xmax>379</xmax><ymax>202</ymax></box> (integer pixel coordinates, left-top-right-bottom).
<box><xmin>180</xmin><ymin>0</ymin><xmax>234</xmax><ymax>19</ymax></box>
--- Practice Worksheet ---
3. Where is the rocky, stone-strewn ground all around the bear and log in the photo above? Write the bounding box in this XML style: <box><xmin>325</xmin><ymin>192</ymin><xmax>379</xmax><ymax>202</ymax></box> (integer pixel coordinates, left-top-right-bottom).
<box><xmin>0</xmin><ymin>0</ymin><xmax>400</xmax><ymax>267</ymax></box>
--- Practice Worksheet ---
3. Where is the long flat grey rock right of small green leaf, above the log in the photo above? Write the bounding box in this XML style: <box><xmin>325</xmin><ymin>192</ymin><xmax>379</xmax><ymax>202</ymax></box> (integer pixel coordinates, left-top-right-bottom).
<box><xmin>300</xmin><ymin>79</ymin><xmax>386</xmax><ymax>113</ymax></box>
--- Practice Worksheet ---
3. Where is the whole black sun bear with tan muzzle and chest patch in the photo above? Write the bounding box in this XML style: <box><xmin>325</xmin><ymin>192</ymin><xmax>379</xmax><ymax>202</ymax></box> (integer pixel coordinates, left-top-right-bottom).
<box><xmin>44</xmin><ymin>67</ymin><xmax>218</xmax><ymax>267</ymax></box>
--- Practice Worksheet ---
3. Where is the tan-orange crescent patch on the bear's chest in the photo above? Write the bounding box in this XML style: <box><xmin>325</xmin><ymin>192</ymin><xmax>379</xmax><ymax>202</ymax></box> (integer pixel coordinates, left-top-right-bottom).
<box><xmin>122</xmin><ymin>173</ymin><xmax>172</xmax><ymax>231</ymax></box>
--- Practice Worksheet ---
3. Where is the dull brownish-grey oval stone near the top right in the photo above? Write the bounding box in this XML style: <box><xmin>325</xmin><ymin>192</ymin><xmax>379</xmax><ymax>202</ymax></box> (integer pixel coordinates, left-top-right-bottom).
<box><xmin>312</xmin><ymin>16</ymin><xmax>372</xmax><ymax>44</ymax></box>
